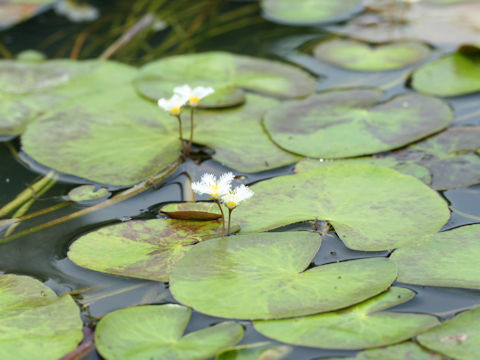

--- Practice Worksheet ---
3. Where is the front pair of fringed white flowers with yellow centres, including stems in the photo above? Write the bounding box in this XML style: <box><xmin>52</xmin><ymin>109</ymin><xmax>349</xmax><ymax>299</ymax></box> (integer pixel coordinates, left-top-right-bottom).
<box><xmin>192</xmin><ymin>172</ymin><xmax>254</xmax><ymax>236</ymax></box>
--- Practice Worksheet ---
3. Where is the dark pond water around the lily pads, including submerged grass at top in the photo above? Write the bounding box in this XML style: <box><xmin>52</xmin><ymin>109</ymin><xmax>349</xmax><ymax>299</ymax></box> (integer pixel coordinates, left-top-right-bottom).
<box><xmin>0</xmin><ymin>0</ymin><xmax>480</xmax><ymax>360</ymax></box>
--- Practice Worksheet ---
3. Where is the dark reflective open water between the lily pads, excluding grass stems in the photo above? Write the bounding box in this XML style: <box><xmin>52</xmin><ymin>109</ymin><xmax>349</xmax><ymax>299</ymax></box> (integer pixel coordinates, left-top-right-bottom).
<box><xmin>0</xmin><ymin>1</ymin><xmax>480</xmax><ymax>360</ymax></box>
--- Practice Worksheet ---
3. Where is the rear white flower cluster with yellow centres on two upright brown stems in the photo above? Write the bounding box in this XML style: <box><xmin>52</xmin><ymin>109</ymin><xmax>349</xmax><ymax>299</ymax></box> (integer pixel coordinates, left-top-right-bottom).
<box><xmin>158</xmin><ymin>85</ymin><xmax>215</xmax><ymax>156</ymax></box>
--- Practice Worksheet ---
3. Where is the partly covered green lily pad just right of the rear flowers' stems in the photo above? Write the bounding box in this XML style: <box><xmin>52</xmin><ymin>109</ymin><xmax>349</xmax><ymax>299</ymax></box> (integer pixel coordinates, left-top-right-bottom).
<box><xmin>190</xmin><ymin>95</ymin><xmax>301</xmax><ymax>173</ymax></box>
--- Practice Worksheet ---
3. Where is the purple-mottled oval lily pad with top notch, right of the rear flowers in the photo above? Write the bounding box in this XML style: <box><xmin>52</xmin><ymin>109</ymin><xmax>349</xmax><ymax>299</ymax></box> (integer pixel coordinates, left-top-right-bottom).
<box><xmin>264</xmin><ymin>88</ymin><xmax>453</xmax><ymax>158</ymax></box>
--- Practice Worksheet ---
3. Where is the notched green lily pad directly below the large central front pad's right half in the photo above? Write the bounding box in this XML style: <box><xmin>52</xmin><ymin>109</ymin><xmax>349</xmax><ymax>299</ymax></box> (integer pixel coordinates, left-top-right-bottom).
<box><xmin>254</xmin><ymin>287</ymin><xmax>439</xmax><ymax>350</ymax></box>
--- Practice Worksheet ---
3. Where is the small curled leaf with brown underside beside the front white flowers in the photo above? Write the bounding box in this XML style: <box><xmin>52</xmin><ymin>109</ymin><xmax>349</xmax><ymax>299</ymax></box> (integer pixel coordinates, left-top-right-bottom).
<box><xmin>160</xmin><ymin>202</ymin><xmax>222</xmax><ymax>221</ymax></box>
